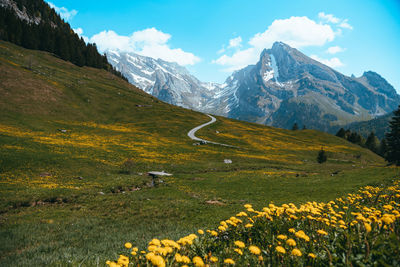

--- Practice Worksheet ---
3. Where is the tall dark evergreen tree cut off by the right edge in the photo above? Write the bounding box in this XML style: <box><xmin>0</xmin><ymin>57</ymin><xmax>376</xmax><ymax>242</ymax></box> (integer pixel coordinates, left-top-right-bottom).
<box><xmin>386</xmin><ymin>106</ymin><xmax>400</xmax><ymax>166</ymax></box>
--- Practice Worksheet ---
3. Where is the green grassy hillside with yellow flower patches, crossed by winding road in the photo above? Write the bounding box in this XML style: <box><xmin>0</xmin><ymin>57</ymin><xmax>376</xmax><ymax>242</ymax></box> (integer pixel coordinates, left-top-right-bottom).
<box><xmin>0</xmin><ymin>42</ymin><xmax>397</xmax><ymax>266</ymax></box>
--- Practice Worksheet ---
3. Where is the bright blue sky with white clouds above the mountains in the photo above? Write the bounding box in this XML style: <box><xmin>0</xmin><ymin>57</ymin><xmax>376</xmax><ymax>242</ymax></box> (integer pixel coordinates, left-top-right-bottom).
<box><xmin>47</xmin><ymin>0</ymin><xmax>400</xmax><ymax>93</ymax></box>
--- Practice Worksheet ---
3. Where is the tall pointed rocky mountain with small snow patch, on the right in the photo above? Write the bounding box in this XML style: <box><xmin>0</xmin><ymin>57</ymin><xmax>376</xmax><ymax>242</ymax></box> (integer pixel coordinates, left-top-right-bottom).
<box><xmin>208</xmin><ymin>42</ymin><xmax>400</xmax><ymax>131</ymax></box>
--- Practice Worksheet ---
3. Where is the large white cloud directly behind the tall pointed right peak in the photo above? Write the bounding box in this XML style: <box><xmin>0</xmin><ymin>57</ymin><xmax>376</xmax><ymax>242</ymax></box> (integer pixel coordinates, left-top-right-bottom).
<box><xmin>213</xmin><ymin>17</ymin><xmax>336</xmax><ymax>71</ymax></box>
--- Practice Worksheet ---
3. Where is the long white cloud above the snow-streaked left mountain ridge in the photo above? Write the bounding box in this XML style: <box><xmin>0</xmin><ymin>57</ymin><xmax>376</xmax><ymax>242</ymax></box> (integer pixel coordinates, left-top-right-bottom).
<box><xmin>90</xmin><ymin>28</ymin><xmax>200</xmax><ymax>66</ymax></box>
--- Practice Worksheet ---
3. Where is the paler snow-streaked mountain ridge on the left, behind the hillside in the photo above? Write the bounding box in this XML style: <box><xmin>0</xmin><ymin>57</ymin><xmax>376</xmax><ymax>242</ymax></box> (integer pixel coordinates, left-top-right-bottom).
<box><xmin>106</xmin><ymin>50</ymin><xmax>220</xmax><ymax>110</ymax></box>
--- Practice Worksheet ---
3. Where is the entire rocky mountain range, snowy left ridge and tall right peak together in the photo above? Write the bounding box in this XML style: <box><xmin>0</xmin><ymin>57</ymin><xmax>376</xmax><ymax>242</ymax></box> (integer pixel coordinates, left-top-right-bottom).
<box><xmin>107</xmin><ymin>42</ymin><xmax>400</xmax><ymax>131</ymax></box>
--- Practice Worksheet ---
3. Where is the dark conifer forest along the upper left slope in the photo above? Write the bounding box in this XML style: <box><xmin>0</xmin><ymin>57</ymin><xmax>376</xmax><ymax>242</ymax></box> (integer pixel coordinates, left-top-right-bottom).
<box><xmin>0</xmin><ymin>0</ymin><xmax>127</xmax><ymax>80</ymax></box>
